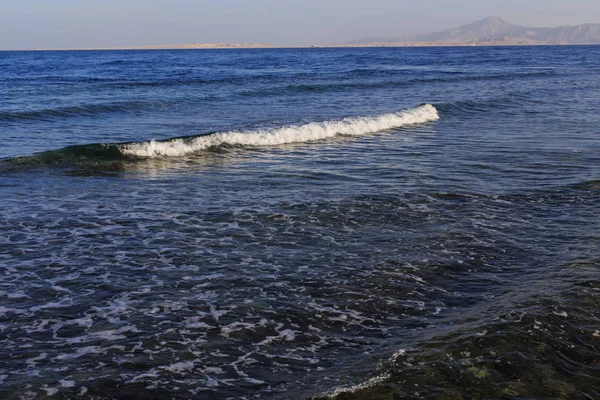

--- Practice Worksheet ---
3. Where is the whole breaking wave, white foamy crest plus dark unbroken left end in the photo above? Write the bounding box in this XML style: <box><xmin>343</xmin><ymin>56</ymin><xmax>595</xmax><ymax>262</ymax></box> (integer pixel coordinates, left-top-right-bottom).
<box><xmin>0</xmin><ymin>104</ymin><xmax>439</xmax><ymax>172</ymax></box>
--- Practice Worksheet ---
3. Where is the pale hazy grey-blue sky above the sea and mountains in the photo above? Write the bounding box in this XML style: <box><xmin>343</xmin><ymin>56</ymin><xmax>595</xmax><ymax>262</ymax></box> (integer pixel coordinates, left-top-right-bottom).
<box><xmin>0</xmin><ymin>0</ymin><xmax>600</xmax><ymax>49</ymax></box>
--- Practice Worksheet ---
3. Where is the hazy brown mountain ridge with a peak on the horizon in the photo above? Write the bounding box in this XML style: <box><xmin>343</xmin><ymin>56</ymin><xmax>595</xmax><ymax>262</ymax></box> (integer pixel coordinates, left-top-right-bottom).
<box><xmin>348</xmin><ymin>17</ymin><xmax>600</xmax><ymax>45</ymax></box>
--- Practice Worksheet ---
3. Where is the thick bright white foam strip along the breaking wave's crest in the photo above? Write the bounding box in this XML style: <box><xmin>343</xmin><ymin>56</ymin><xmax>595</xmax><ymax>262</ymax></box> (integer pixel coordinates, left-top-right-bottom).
<box><xmin>119</xmin><ymin>104</ymin><xmax>439</xmax><ymax>157</ymax></box>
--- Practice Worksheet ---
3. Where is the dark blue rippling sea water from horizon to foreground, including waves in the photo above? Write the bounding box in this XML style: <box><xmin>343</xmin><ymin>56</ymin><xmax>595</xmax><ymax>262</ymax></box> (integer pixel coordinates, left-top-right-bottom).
<box><xmin>0</xmin><ymin>46</ymin><xmax>600</xmax><ymax>400</ymax></box>
